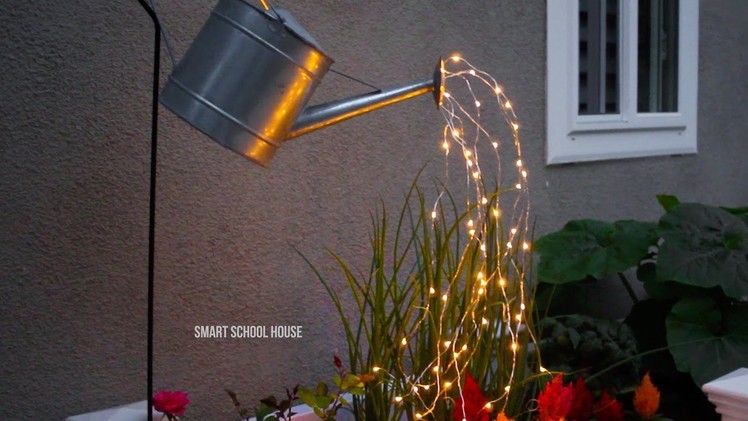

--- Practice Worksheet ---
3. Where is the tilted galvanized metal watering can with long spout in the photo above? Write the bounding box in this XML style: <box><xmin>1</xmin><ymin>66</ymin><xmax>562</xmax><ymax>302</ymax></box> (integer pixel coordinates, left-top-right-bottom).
<box><xmin>160</xmin><ymin>0</ymin><xmax>444</xmax><ymax>166</ymax></box>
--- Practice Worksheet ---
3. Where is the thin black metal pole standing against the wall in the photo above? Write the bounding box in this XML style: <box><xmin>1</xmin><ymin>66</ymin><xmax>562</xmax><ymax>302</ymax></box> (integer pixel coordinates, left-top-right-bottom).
<box><xmin>138</xmin><ymin>0</ymin><xmax>161</xmax><ymax>421</ymax></box>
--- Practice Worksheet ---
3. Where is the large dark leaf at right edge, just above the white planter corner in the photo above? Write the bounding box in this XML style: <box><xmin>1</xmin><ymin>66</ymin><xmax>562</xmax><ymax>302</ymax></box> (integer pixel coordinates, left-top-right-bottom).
<box><xmin>666</xmin><ymin>297</ymin><xmax>748</xmax><ymax>386</ymax></box>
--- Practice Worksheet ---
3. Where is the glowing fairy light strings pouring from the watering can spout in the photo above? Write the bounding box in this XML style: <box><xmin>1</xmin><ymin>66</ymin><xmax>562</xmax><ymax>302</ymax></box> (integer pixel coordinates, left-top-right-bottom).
<box><xmin>375</xmin><ymin>54</ymin><xmax>542</xmax><ymax>419</ymax></box>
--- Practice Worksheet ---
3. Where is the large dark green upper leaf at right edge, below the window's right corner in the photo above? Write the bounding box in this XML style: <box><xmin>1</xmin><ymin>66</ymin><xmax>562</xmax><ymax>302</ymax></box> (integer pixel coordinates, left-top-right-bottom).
<box><xmin>657</xmin><ymin>203</ymin><xmax>748</xmax><ymax>298</ymax></box>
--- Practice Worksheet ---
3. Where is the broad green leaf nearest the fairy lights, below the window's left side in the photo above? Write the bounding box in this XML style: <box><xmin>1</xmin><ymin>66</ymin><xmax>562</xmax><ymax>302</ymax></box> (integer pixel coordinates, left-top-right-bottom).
<box><xmin>534</xmin><ymin>219</ymin><xmax>657</xmax><ymax>284</ymax></box>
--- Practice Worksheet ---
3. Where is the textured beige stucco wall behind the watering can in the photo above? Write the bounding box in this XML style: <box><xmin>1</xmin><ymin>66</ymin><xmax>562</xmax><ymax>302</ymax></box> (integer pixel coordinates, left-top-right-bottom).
<box><xmin>0</xmin><ymin>0</ymin><xmax>748</xmax><ymax>420</ymax></box>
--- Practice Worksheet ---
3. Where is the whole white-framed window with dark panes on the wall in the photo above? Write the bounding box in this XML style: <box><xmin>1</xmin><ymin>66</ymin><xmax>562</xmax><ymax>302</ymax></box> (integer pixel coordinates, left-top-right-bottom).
<box><xmin>546</xmin><ymin>0</ymin><xmax>699</xmax><ymax>164</ymax></box>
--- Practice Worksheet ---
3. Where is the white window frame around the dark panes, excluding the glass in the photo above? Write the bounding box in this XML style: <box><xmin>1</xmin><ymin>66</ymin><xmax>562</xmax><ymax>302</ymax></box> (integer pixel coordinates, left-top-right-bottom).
<box><xmin>546</xmin><ymin>0</ymin><xmax>699</xmax><ymax>165</ymax></box>
